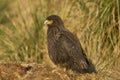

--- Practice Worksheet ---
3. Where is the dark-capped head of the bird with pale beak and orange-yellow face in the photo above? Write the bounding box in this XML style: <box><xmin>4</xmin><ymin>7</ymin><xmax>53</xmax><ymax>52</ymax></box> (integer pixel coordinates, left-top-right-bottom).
<box><xmin>44</xmin><ymin>15</ymin><xmax>64</xmax><ymax>27</ymax></box>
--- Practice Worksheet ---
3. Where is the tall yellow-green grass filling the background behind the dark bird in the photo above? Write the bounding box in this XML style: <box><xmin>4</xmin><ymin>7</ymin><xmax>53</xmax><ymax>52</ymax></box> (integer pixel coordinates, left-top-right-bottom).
<box><xmin>0</xmin><ymin>0</ymin><xmax>120</xmax><ymax>78</ymax></box>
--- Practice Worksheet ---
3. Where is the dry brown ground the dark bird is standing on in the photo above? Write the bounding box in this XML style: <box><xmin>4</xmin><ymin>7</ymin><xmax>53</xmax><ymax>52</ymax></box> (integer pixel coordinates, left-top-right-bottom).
<box><xmin>0</xmin><ymin>62</ymin><xmax>120</xmax><ymax>80</ymax></box>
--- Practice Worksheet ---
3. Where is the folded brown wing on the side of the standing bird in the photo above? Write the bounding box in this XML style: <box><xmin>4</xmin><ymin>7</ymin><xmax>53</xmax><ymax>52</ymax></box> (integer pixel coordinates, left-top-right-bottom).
<box><xmin>60</xmin><ymin>30</ymin><xmax>89</xmax><ymax>69</ymax></box>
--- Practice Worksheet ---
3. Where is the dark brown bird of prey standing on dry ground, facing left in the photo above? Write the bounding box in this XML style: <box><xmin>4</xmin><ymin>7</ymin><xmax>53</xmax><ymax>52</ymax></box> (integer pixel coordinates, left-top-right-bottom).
<box><xmin>44</xmin><ymin>15</ymin><xmax>96</xmax><ymax>73</ymax></box>
